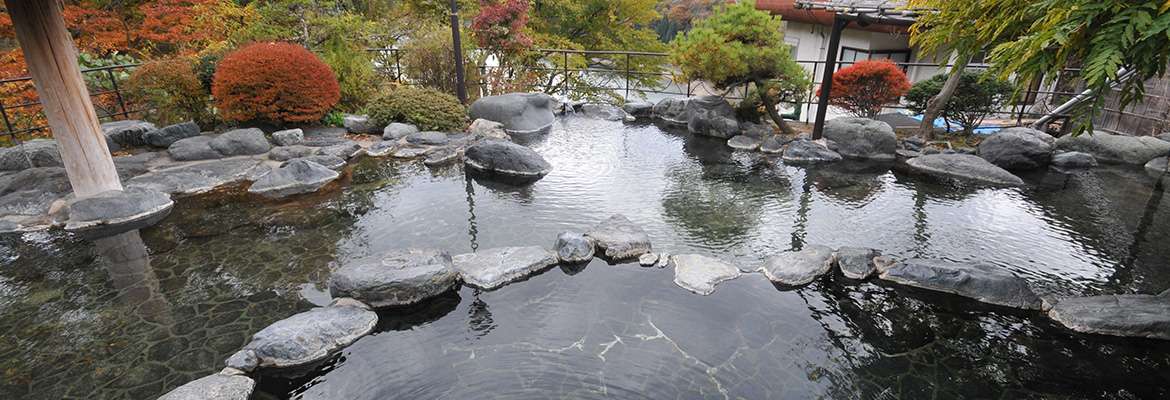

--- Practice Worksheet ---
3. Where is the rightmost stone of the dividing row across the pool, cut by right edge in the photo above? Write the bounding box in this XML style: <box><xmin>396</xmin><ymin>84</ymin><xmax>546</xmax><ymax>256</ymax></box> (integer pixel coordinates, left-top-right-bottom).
<box><xmin>1048</xmin><ymin>291</ymin><xmax>1170</xmax><ymax>339</ymax></box>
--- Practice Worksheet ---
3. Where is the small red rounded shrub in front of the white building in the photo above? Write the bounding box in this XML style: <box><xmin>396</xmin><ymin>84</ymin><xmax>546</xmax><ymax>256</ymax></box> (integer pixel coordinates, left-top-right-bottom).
<box><xmin>820</xmin><ymin>58</ymin><xmax>910</xmax><ymax>118</ymax></box>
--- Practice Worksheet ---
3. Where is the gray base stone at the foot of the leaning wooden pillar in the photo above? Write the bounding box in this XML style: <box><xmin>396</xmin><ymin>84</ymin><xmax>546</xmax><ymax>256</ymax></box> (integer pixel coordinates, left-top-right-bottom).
<box><xmin>66</xmin><ymin>187</ymin><xmax>174</xmax><ymax>236</ymax></box>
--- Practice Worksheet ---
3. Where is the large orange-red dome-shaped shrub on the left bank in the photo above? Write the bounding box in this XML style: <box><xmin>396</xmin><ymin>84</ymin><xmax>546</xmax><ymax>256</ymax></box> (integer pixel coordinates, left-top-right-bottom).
<box><xmin>212</xmin><ymin>42</ymin><xmax>340</xmax><ymax>123</ymax></box>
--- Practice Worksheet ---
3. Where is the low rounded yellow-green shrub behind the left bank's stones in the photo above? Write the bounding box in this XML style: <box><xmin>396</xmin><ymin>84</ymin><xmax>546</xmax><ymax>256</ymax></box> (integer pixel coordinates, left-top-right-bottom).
<box><xmin>366</xmin><ymin>88</ymin><xmax>467</xmax><ymax>132</ymax></box>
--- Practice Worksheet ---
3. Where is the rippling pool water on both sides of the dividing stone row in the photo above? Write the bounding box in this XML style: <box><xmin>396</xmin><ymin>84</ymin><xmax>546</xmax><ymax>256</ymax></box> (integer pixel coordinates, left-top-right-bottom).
<box><xmin>0</xmin><ymin>117</ymin><xmax>1170</xmax><ymax>399</ymax></box>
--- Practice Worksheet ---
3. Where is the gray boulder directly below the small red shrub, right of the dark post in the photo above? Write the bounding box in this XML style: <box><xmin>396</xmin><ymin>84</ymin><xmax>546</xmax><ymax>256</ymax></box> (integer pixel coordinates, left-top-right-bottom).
<box><xmin>824</xmin><ymin>117</ymin><xmax>897</xmax><ymax>161</ymax></box>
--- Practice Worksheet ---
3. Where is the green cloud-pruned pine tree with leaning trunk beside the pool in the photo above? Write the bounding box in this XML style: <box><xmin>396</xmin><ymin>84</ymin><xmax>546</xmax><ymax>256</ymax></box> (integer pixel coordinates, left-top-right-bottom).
<box><xmin>670</xmin><ymin>0</ymin><xmax>812</xmax><ymax>135</ymax></box>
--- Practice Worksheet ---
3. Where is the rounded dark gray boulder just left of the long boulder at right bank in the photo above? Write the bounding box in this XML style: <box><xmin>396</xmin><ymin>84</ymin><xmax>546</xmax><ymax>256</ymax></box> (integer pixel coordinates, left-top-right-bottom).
<box><xmin>976</xmin><ymin>127</ymin><xmax>1055</xmax><ymax>170</ymax></box>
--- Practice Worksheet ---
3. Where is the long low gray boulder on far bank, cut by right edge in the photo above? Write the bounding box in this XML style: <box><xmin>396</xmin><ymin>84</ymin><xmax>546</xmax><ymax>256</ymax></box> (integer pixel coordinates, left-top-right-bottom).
<box><xmin>1057</xmin><ymin>132</ymin><xmax>1170</xmax><ymax>165</ymax></box>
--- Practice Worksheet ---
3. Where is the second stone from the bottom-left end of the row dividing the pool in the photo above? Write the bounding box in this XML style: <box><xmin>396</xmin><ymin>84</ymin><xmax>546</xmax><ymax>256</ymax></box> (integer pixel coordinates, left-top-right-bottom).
<box><xmin>243</xmin><ymin>306</ymin><xmax>378</xmax><ymax>367</ymax></box>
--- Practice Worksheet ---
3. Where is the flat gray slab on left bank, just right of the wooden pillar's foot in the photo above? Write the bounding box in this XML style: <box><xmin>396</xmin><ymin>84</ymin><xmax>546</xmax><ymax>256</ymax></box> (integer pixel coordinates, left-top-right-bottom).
<box><xmin>124</xmin><ymin>158</ymin><xmax>261</xmax><ymax>195</ymax></box>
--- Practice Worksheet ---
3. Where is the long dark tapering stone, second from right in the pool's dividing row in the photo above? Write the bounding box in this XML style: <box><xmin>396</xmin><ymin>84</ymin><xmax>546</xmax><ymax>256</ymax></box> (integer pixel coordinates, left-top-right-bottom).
<box><xmin>878</xmin><ymin>258</ymin><xmax>1042</xmax><ymax>310</ymax></box>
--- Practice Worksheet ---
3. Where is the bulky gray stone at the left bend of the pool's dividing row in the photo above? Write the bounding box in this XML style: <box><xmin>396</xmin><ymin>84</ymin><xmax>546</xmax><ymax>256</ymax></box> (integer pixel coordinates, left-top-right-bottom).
<box><xmin>329</xmin><ymin>249</ymin><xmax>459</xmax><ymax>308</ymax></box>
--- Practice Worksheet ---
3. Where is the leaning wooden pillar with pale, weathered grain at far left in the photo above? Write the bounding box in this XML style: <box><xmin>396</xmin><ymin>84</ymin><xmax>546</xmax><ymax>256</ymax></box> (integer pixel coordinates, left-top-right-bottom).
<box><xmin>5</xmin><ymin>0</ymin><xmax>122</xmax><ymax>198</ymax></box>
